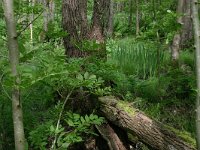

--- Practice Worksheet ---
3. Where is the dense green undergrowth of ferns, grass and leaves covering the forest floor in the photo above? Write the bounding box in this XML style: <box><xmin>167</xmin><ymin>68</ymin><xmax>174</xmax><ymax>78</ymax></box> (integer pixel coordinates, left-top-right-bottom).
<box><xmin>1</xmin><ymin>38</ymin><xmax>195</xmax><ymax>149</ymax></box>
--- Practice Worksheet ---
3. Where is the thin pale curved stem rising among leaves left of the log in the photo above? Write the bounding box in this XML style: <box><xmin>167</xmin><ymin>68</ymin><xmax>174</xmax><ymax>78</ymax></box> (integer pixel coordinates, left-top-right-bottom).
<box><xmin>51</xmin><ymin>89</ymin><xmax>73</xmax><ymax>150</ymax></box>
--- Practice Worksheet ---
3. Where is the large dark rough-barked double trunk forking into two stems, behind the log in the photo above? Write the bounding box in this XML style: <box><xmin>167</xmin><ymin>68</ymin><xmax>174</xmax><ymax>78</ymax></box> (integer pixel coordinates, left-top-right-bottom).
<box><xmin>62</xmin><ymin>0</ymin><xmax>110</xmax><ymax>57</ymax></box>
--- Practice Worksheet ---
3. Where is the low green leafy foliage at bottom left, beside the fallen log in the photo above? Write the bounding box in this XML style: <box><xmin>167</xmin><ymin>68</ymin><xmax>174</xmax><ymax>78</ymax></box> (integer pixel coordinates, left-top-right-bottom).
<box><xmin>29</xmin><ymin>112</ymin><xmax>103</xmax><ymax>150</ymax></box>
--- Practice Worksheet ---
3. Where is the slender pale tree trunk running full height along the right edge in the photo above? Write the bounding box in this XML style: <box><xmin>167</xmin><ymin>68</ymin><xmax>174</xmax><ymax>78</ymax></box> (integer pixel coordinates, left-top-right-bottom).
<box><xmin>192</xmin><ymin>0</ymin><xmax>200</xmax><ymax>150</ymax></box>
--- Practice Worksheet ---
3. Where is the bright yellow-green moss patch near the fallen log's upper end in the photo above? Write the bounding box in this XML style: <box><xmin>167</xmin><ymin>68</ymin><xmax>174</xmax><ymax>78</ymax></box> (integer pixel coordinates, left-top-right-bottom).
<box><xmin>117</xmin><ymin>101</ymin><xmax>137</xmax><ymax>116</ymax></box>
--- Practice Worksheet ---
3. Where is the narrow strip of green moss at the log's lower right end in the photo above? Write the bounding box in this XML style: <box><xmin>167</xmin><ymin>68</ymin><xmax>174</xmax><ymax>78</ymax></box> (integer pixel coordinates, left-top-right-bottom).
<box><xmin>165</xmin><ymin>125</ymin><xmax>196</xmax><ymax>148</ymax></box>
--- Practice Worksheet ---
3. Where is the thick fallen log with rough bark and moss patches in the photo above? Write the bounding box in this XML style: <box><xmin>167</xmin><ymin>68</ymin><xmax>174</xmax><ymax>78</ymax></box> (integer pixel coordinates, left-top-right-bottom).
<box><xmin>99</xmin><ymin>97</ymin><xmax>196</xmax><ymax>150</ymax></box>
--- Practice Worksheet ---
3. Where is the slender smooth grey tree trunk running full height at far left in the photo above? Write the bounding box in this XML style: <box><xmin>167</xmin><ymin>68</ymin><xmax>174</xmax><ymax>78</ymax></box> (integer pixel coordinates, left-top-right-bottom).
<box><xmin>3</xmin><ymin>0</ymin><xmax>25</xmax><ymax>150</ymax></box>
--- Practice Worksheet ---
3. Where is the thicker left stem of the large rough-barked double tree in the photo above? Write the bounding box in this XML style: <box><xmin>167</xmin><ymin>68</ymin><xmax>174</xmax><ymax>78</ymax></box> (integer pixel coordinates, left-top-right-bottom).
<box><xmin>62</xmin><ymin>0</ymin><xmax>88</xmax><ymax>57</ymax></box>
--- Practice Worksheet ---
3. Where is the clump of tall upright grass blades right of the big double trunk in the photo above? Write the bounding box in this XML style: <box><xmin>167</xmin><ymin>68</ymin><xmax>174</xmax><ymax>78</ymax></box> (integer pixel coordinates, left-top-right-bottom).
<box><xmin>108</xmin><ymin>38</ymin><xmax>165</xmax><ymax>79</ymax></box>
